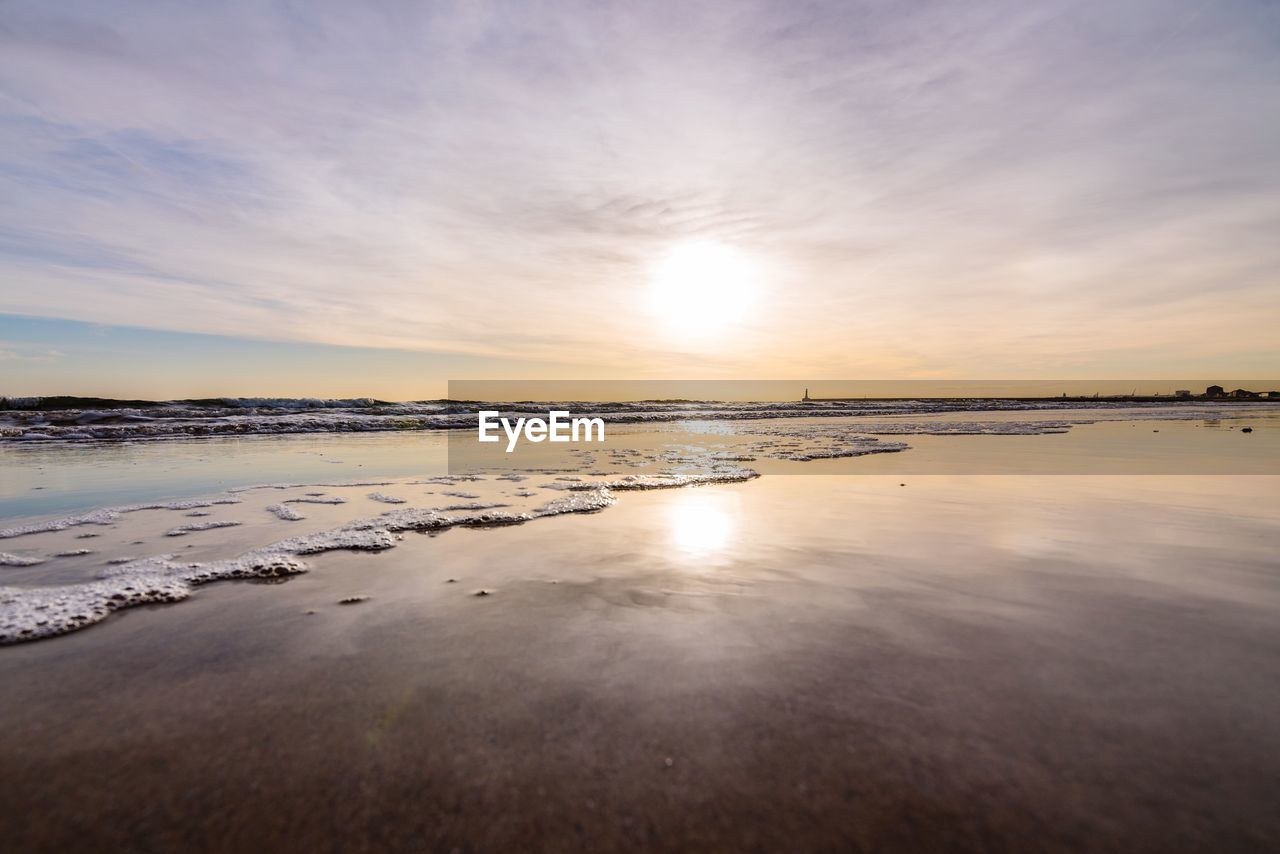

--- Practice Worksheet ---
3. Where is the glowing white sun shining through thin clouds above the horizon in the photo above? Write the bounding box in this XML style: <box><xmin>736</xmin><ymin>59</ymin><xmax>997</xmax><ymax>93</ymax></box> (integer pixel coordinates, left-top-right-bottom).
<box><xmin>649</xmin><ymin>241</ymin><xmax>759</xmax><ymax>335</ymax></box>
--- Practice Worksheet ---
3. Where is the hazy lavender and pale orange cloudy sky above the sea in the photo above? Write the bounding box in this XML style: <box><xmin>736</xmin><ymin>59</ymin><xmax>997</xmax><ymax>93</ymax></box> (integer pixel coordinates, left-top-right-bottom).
<box><xmin>0</xmin><ymin>0</ymin><xmax>1280</xmax><ymax>399</ymax></box>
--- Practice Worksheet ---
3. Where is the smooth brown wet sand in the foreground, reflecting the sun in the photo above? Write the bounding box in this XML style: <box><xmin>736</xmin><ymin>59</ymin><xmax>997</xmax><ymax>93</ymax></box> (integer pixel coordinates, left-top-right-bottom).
<box><xmin>0</xmin><ymin>475</ymin><xmax>1280</xmax><ymax>851</ymax></box>
